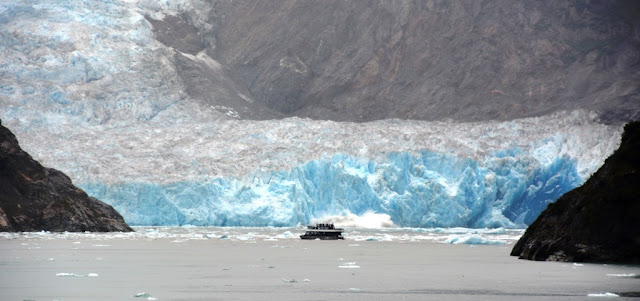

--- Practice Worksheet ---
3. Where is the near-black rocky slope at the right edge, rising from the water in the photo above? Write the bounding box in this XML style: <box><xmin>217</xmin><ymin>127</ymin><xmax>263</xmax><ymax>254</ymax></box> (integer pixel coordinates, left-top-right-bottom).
<box><xmin>511</xmin><ymin>122</ymin><xmax>640</xmax><ymax>263</ymax></box>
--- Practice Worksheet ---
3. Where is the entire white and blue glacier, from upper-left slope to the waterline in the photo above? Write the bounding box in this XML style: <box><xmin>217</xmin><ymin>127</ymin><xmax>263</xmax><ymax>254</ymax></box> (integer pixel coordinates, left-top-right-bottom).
<box><xmin>0</xmin><ymin>0</ymin><xmax>621</xmax><ymax>228</ymax></box>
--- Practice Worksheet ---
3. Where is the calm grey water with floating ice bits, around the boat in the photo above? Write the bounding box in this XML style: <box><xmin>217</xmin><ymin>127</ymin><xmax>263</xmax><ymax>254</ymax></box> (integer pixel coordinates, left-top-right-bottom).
<box><xmin>0</xmin><ymin>227</ymin><xmax>640</xmax><ymax>301</ymax></box>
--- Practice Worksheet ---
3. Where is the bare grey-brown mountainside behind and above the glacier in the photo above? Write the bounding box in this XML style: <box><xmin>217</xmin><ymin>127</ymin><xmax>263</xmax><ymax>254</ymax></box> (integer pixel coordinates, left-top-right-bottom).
<box><xmin>150</xmin><ymin>0</ymin><xmax>640</xmax><ymax>122</ymax></box>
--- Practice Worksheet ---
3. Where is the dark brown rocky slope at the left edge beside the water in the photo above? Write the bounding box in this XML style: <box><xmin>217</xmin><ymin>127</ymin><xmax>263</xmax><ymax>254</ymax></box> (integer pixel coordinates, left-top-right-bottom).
<box><xmin>0</xmin><ymin>123</ymin><xmax>132</xmax><ymax>232</ymax></box>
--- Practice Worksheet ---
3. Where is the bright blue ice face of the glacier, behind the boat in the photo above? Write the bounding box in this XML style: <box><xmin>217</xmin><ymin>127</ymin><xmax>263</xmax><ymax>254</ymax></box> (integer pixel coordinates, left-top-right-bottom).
<box><xmin>80</xmin><ymin>146</ymin><xmax>583</xmax><ymax>228</ymax></box>
